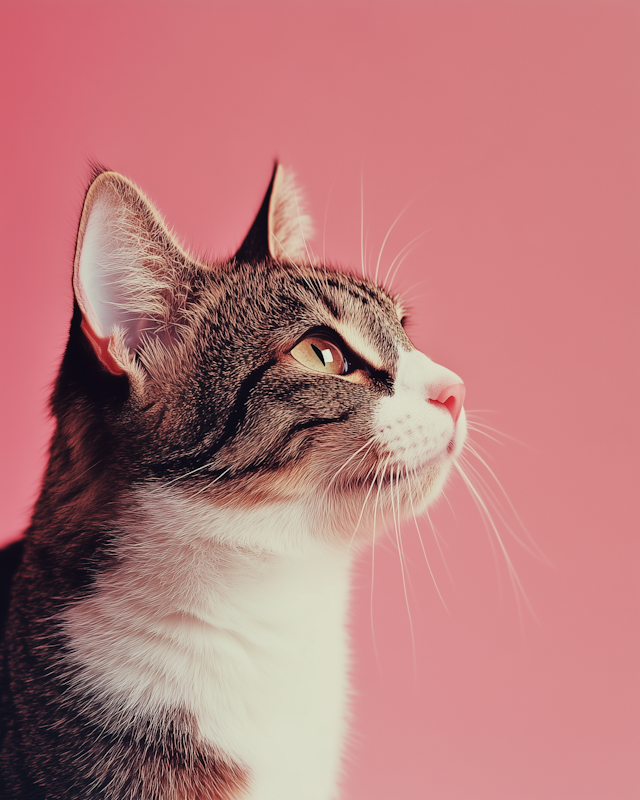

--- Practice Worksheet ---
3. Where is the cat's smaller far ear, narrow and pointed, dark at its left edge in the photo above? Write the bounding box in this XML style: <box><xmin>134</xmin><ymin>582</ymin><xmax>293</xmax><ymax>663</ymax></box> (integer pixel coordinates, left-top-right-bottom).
<box><xmin>236</xmin><ymin>163</ymin><xmax>313</xmax><ymax>262</ymax></box>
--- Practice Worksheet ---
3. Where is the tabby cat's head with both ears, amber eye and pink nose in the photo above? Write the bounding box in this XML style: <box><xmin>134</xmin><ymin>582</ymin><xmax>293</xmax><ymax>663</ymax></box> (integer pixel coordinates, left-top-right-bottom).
<box><xmin>65</xmin><ymin>165</ymin><xmax>466</xmax><ymax>552</ymax></box>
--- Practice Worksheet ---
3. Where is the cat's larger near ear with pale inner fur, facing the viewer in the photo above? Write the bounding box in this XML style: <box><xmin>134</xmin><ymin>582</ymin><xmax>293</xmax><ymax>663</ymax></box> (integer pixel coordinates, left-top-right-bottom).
<box><xmin>73</xmin><ymin>172</ymin><xmax>184</xmax><ymax>375</ymax></box>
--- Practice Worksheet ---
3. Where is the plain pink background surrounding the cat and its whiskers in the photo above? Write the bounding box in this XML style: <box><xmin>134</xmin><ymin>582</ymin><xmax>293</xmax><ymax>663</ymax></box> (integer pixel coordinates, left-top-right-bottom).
<box><xmin>0</xmin><ymin>0</ymin><xmax>640</xmax><ymax>800</ymax></box>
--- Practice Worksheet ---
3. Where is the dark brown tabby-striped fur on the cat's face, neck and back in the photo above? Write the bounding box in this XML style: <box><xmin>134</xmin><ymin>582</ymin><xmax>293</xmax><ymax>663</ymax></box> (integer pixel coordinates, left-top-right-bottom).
<box><xmin>0</xmin><ymin>166</ymin><xmax>408</xmax><ymax>800</ymax></box>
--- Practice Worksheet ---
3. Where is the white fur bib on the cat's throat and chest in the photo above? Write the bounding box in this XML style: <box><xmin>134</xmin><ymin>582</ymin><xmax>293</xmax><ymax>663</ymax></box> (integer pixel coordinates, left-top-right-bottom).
<box><xmin>63</xmin><ymin>486</ymin><xmax>349</xmax><ymax>800</ymax></box>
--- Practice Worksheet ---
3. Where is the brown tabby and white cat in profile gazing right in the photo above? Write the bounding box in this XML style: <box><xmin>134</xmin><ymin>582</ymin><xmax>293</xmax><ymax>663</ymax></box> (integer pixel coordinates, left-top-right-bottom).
<box><xmin>0</xmin><ymin>164</ymin><xmax>466</xmax><ymax>800</ymax></box>
